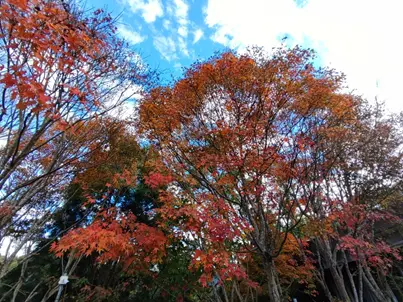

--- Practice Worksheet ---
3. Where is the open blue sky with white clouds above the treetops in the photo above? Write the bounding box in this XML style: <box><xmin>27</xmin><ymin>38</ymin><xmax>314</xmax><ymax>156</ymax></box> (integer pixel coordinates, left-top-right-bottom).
<box><xmin>86</xmin><ymin>0</ymin><xmax>403</xmax><ymax>111</ymax></box>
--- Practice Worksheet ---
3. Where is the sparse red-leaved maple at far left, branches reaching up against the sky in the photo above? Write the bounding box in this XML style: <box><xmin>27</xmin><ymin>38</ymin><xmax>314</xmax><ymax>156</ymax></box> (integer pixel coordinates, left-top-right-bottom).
<box><xmin>0</xmin><ymin>0</ymin><xmax>145</xmax><ymax>278</ymax></box>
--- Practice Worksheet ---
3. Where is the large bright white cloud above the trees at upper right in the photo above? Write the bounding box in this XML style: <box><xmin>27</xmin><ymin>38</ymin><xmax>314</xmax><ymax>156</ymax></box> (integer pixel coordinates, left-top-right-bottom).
<box><xmin>205</xmin><ymin>0</ymin><xmax>403</xmax><ymax>111</ymax></box>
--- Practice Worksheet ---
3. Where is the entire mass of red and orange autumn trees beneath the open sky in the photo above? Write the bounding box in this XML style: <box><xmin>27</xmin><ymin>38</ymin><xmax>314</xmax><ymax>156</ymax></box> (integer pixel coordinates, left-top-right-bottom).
<box><xmin>0</xmin><ymin>0</ymin><xmax>403</xmax><ymax>302</ymax></box>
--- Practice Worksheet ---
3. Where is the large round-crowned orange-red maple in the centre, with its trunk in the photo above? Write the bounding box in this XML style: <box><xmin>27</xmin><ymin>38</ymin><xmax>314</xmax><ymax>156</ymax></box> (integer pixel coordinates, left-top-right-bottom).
<box><xmin>139</xmin><ymin>47</ymin><xmax>359</xmax><ymax>301</ymax></box>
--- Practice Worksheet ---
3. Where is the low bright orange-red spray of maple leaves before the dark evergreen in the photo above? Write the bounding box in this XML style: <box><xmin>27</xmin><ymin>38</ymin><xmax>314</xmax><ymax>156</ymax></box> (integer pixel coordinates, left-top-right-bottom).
<box><xmin>51</xmin><ymin>208</ymin><xmax>166</xmax><ymax>270</ymax></box>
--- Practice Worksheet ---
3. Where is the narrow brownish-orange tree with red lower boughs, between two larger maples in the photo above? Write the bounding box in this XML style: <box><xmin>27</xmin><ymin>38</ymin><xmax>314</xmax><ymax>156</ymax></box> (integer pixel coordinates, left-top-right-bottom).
<box><xmin>43</xmin><ymin>124</ymin><xmax>167</xmax><ymax>300</ymax></box>
